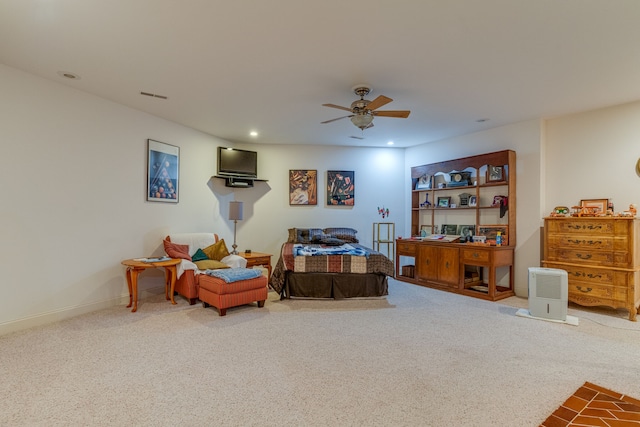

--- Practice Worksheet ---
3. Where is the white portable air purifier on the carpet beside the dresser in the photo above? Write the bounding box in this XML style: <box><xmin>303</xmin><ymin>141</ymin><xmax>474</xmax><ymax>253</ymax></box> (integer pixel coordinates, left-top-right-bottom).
<box><xmin>529</xmin><ymin>267</ymin><xmax>569</xmax><ymax>322</ymax></box>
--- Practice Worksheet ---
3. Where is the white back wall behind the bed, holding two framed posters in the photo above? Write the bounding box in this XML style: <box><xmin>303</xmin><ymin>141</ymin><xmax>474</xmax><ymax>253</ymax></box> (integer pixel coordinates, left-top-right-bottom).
<box><xmin>228</xmin><ymin>144</ymin><xmax>406</xmax><ymax>254</ymax></box>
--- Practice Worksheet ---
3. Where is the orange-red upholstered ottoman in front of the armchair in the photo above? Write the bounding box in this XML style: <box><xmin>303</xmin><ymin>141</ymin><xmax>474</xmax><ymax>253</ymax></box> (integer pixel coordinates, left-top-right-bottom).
<box><xmin>198</xmin><ymin>274</ymin><xmax>267</xmax><ymax>316</ymax></box>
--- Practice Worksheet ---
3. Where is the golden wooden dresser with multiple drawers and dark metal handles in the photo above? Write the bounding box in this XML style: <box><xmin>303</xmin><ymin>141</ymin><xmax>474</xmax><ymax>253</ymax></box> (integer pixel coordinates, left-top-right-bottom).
<box><xmin>542</xmin><ymin>217</ymin><xmax>640</xmax><ymax>321</ymax></box>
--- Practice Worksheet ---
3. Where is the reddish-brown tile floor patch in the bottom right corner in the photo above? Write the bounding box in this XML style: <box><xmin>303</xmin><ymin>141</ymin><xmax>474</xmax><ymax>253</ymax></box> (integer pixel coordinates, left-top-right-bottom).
<box><xmin>540</xmin><ymin>382</ymin><xmax>640</xmax><ymax>427</ymax></box>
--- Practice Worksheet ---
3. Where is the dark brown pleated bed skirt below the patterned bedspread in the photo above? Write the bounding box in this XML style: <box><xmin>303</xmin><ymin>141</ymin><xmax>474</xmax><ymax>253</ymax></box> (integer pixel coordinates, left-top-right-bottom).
<box><xmin>283</xmin><ymin>271</ymin><xmax>389</xmax><ymax>299</ymax></box>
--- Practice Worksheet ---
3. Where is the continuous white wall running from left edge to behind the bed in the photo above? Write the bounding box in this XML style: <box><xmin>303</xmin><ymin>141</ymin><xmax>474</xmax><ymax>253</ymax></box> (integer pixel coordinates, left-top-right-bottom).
<box><xmin>0</xmin><ymin>65</ymin><xmax>405</xmax><ymax>333</ymax></box>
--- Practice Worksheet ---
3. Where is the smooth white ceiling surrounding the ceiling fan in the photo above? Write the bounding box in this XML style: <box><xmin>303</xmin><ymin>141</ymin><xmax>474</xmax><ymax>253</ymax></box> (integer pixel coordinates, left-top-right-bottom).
<box><xmin>0</xmin><ymin>0</ymin><xmax>640</xmax><ymax>147</ymax></box>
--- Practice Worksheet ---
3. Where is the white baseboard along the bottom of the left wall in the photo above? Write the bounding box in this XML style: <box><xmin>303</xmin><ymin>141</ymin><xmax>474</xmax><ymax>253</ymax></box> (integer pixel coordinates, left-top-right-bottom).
<box><xmin>0</xmin><ymin>285</ymin><xmax>164</xmax><ymax>336</ymax></box>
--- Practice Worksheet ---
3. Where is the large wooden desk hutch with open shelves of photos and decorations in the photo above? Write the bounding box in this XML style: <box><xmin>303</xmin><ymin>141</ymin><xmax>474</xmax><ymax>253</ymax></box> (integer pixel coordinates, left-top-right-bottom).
<box><xmin>396</xmin><ymin>150</ymin><xmax>516</xmax><ymax>301</ymax></box>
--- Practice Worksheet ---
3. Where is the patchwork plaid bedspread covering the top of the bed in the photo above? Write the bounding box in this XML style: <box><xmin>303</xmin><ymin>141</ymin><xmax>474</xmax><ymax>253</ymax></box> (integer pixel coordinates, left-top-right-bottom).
<box><xmin>269</xmin><ymin>243</ymin><xmax>394</xmax><ymax>294</ymax></box>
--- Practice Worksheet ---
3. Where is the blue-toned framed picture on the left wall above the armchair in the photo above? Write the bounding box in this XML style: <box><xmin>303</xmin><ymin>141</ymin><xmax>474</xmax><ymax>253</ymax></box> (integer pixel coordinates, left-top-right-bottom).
<box><xmin>147</xmin><ymin>139</ymin><xmax>180</xmax><ymax>203</ymax></box>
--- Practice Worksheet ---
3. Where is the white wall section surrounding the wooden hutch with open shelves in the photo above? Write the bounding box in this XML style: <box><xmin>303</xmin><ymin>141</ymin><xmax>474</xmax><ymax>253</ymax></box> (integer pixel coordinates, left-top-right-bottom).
<box><xmin>404</xmin><ymin>120</ymin><xmax>542</xmax><ymax>296</ymax></box>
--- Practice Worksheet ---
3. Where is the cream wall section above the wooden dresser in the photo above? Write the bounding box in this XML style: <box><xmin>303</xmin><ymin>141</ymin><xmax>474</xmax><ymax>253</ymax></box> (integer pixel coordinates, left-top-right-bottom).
<box><xmin>544</xmin><ymin>102</ymin><xmax>640</xmax><ymax>213</ymax></box>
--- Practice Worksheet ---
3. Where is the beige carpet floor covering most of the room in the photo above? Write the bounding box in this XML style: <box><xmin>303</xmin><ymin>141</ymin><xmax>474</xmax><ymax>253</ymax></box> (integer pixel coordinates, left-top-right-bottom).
<box><xmin>0</xmin><ymin>280</ymin><xmax>640</xmax><ymax>427</ymax></box>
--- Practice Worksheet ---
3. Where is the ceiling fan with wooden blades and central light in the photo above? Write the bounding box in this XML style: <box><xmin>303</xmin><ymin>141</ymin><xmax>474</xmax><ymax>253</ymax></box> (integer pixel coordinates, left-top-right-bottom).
<box><xmin>321</xmin><ymin>85</ymin><xmax>411</xmax><ymax>131</ymax></box>
